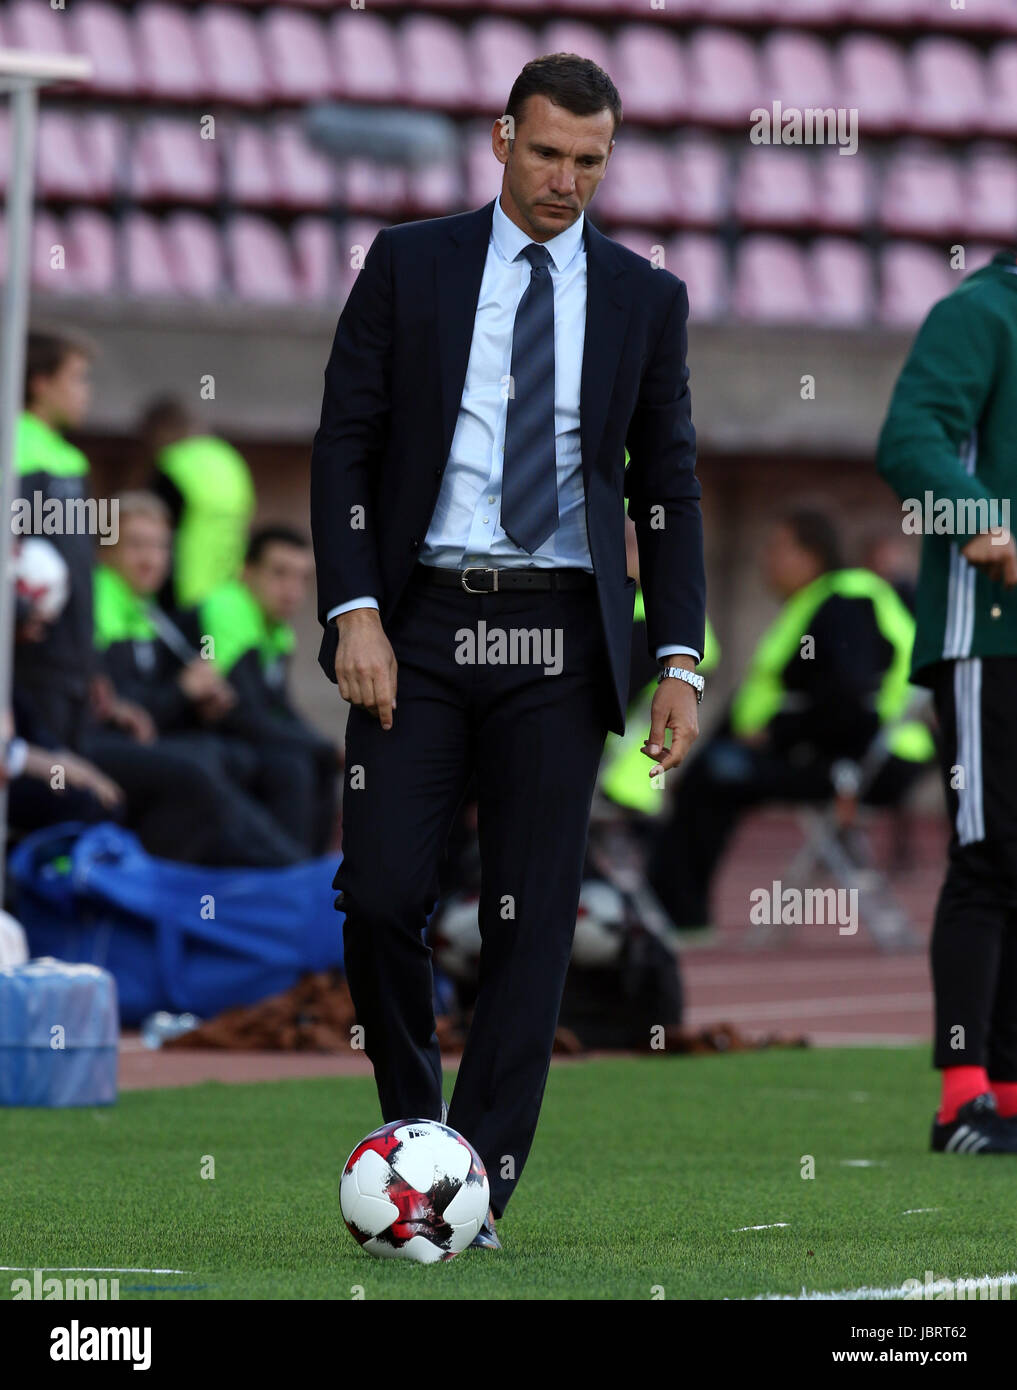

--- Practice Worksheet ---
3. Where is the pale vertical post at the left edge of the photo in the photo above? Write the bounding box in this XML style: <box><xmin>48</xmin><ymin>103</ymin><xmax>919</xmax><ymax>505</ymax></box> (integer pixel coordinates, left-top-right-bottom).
<box><xmin>0</xmin><ymin>78</ymin><xmax>38</xmax><ymax>905</ymax></box>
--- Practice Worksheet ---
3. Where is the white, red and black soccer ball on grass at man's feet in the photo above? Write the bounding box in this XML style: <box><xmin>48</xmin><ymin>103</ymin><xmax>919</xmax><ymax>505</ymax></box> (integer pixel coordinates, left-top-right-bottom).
<box><xmin>339</xmin><ymin>1120</ymin><xmax>490</xmax><ymax>1265</ymax></box>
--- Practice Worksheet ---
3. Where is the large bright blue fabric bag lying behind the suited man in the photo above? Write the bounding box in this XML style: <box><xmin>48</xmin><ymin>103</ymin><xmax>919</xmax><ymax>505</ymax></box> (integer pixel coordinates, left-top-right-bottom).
<box><xmin>10</xmin><ymin>824</ymin><xmax>343</xmax><ymax>1024</ymax></box>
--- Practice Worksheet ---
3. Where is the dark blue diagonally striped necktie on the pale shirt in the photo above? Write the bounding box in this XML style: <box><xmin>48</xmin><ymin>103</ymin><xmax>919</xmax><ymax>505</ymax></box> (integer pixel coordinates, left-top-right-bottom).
<box><xmin>502</xmin><ymin>242</ymin><xmax>559</xmax><ymax>555</ymax></box>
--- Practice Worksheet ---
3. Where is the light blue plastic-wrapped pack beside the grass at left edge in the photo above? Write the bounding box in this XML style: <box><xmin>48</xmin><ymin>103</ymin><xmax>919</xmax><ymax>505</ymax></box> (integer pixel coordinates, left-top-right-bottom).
<box><xmin>0</xmin><ymin>958</ymin><xmax>119</xmax><ymax>1106</ymax></box>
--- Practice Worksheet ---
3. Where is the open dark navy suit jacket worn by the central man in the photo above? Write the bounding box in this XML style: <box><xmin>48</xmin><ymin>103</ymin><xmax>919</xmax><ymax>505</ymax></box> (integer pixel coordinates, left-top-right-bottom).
<box><xmin>311</xmin><ymin>202</ymin><xmax>706</xmax><ymax>733</ymax></box>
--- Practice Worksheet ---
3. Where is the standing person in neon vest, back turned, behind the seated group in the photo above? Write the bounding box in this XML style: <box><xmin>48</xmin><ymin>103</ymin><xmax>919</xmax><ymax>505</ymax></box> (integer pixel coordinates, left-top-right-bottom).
<box><xmin>140</xmin><ymin>396</ymin><xmax>256</xmax><ymax>607</ymax></box>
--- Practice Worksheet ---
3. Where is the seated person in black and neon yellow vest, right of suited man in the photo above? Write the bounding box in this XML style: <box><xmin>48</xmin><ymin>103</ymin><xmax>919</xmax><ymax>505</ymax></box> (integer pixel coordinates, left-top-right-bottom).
<box><xmin>646</xmin><ymin>507</ymin><xmax>935</xmax><ymax>930</ymax></box>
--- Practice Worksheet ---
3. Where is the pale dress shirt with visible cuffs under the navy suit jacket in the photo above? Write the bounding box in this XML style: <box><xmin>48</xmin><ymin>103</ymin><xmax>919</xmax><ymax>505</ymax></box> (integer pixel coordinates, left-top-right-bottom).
<box><xmin>328</xmin><ymin>197</ymin><xmax>700</xmax><ymax>662</ymax></box>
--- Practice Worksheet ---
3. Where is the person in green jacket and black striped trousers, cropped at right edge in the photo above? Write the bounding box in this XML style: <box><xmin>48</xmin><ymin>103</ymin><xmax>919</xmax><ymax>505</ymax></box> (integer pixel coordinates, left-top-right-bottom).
<box><xmin>877</xmin><ymin>249</ymin><xmax>1017</xmax><ymax>1154</ymax></box>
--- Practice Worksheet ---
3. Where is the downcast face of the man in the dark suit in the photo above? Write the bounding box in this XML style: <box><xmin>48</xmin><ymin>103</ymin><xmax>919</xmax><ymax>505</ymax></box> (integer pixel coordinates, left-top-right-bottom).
<box><xmin>492</xmin><ymin>96</ymin><xmax>614</xmax><ymax>242</ymax></box>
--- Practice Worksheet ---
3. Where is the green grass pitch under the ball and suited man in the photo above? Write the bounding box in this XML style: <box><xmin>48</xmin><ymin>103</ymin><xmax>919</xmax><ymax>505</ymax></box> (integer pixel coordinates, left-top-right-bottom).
<box><xmin>0</xmin><ymin>1048</ymin><xmax>1017</xmax><ymax>1301</ymax></box>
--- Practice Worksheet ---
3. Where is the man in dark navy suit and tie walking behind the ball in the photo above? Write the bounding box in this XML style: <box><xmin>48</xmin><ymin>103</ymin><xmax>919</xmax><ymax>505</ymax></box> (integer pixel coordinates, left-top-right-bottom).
<box><xmin>311</xmin><ymin>54</ymin><xmax>706</xmax><ymax>1247</ymax></box>
